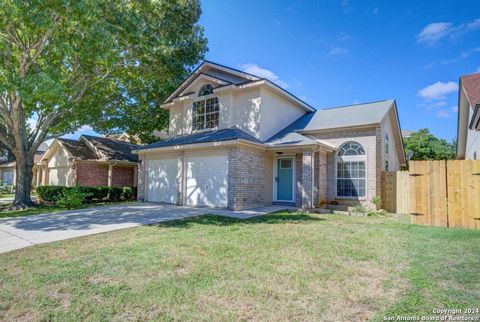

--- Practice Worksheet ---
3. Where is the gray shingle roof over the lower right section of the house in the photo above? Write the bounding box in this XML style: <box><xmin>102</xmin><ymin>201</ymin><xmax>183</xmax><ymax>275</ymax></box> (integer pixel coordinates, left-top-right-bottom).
<box><xmin>267</xmin><ymin>100</ymin><xmax>394</xmax><ymax>142</ymax></box>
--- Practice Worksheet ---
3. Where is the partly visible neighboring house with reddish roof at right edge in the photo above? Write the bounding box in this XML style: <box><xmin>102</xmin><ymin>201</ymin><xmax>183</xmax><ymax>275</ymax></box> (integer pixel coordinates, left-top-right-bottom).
<box><xmin>457</xmin><ymin>73</ymin><xmax>480</xmax><ymax>160</ymax></box>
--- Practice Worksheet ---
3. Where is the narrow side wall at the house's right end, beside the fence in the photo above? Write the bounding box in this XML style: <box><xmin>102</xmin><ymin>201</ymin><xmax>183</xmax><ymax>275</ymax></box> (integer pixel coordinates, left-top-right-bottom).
<box><xmin>380</xmin><ymin>110</ymin><xmax>401</xmax><ymax>171</ymax></box>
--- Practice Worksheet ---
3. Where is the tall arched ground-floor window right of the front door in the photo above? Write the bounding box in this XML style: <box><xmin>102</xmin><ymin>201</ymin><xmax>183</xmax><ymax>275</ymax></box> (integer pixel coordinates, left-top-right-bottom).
<box><xmin>337</xmin><ymin>142</ymin><xmax>366</xmax><ymax>198</ymax></box>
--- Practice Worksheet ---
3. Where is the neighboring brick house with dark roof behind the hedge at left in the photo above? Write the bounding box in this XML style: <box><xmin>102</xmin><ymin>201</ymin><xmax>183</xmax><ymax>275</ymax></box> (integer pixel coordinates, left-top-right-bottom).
<box><xmin>37</xmin><ymin>135</ymin><xmax>138</xmax><ymax>187</ymax></box>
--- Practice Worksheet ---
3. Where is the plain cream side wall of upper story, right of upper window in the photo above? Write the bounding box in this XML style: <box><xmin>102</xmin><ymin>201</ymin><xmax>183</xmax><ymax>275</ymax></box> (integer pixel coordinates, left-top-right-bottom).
<box><xmin>257</xmin><ymin>89</ymin><xmax>306</xmax><ymax>141</ymax></box>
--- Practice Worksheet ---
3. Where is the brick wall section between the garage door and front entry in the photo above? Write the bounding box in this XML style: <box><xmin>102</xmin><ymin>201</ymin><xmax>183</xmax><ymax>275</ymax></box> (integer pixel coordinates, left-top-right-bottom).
<box><xmin>228</xmin><ymin>147</ymin><xmax>265</xmax><ymax>210</ymax></box>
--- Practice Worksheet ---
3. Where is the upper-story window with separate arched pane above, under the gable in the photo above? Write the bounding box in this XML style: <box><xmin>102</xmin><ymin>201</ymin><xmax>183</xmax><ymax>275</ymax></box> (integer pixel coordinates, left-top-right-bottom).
<box><xmin>192</xmin><ymin>84</ymin><xmax>220</xmax><ymax>131</ymax></box>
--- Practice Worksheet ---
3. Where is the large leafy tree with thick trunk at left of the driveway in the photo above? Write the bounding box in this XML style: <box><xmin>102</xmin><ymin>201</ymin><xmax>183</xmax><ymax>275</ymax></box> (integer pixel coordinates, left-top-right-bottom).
<box><xmin>0</xmin><ymin>0</ymin><xmax>207</xmax><ymax>208</ymax></box>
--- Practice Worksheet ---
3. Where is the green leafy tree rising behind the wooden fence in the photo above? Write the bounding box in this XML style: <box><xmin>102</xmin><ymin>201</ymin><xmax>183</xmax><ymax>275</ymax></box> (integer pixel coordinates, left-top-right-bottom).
<box><xmin>403</xmin><ymin>129</ymin><xmax>455</xmax><ymax>160</ymax></box>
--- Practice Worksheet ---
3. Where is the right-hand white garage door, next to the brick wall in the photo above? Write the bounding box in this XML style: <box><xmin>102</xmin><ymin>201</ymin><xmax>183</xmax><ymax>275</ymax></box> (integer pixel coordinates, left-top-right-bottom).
<box><xmin>186</xmin><ymin>155</ymin><xmax>228</xmax><ymax>207</ymax></box>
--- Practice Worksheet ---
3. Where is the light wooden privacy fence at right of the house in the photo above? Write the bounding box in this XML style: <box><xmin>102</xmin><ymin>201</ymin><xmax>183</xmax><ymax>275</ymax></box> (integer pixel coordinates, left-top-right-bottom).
<box><xmin>382</xmin><ymin>160</ymin><xmax>480</xmax><ymax>229</ymax></box>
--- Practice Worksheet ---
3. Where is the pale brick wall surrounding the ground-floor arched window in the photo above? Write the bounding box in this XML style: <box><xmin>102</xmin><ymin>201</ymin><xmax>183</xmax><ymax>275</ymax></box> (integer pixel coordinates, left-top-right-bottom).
<box><xmin>310</xmin><ymin>128</ymin><xmax>380</xmax><ymax>201</ymax></box>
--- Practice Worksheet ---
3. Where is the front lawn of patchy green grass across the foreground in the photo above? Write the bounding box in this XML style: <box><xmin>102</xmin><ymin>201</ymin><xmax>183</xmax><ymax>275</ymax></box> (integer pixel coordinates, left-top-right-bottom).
<box><xmin>0</xmin><ymin>213</ymin><xmax>480</xmax><ymax>321</ymax></box>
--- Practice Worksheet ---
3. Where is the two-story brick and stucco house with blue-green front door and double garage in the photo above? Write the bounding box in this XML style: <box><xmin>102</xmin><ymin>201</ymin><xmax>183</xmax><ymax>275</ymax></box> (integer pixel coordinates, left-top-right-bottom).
<box><xmin>134</xmin><ymin>62</ymin><xmax>405</xmax><ymax>210</ymax></box>
